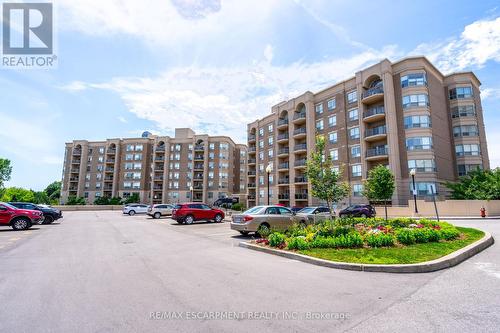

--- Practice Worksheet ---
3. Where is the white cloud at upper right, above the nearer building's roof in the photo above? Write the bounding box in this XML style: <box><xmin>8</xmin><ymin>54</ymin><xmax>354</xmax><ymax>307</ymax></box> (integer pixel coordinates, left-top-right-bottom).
<box><xmin>412</xmin><ymin>17</ymin><xmax>500</xmax><ymax>73</ymax></box>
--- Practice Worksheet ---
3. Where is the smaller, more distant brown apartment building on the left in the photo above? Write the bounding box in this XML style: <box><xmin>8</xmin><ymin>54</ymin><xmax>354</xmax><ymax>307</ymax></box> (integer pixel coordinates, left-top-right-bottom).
<box><xmin>62</xmin><ymin>128</ymin><xmax>247</xmax><ymax>203</ymax></box>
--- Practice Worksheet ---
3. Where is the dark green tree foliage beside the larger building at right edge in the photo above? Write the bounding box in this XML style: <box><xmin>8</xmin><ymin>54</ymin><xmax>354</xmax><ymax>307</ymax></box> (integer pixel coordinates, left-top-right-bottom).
<box><xmin>445</xmin><ymin>168</ymin><xmax>500</xmax><ymax>200</ymax></box>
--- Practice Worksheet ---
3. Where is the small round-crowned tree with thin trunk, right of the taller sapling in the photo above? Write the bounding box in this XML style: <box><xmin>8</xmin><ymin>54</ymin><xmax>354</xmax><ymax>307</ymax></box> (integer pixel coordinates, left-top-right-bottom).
<box><xmin>364</xmin><ymin>165</ymin><xmax>395</xmax><ymax>220</ymax></box>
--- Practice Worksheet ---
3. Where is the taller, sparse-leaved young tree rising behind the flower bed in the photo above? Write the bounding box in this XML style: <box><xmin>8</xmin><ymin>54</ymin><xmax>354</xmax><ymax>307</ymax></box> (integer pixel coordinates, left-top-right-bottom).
<box><xmin>305</xmin><ymin>136</ymin><xmax>350</xmax><ymax>216</ymax></box>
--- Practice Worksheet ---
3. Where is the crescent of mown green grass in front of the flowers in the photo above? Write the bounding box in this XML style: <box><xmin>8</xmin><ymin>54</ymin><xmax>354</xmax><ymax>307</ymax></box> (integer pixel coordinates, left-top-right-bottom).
<box><xmin>298</xmin><ymin>227</ymin><xmax>484</xmax><ymax>264</ymax></box>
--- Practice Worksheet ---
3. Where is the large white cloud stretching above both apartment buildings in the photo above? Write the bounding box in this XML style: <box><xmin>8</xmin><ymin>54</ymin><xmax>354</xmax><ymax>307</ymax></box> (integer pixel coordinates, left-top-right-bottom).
<box><xmin>63</xmin><ymin>45</ymin><xmax>396</xmax><ymax>142</ymax></box>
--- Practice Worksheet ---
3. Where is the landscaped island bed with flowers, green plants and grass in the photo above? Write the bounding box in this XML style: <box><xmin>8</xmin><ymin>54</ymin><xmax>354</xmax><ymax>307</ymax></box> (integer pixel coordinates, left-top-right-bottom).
<box><xmin>256</xmin><ymin>218</ymin><xmax>484</xmax><ymax>263</ymax></box>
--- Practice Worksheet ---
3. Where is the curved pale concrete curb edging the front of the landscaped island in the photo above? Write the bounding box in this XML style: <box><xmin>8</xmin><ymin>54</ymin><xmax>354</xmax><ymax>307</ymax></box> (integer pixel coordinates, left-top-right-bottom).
<box><xmin>239</xmin><ymin>231</ymin><xmax>495</xmax><ymax>273</ymax></box>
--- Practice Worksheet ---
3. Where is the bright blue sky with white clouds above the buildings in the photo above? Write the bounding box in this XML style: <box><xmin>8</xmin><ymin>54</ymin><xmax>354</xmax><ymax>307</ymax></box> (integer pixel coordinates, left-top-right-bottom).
<box><xmin>0</xmin><ymin>0</ymin><xmax>500</xmax><ymax>190</ymax></box>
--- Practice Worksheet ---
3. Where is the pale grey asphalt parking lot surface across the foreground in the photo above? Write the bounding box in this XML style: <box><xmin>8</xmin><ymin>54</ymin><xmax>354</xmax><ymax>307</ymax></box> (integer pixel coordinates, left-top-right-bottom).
<box><xmin>0</xmin><ymin>211</ymin><xmax>500</xmax><ymax>332</ymax></box>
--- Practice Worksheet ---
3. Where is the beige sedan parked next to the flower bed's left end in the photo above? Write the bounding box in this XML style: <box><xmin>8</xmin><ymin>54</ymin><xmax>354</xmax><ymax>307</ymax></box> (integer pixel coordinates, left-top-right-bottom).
<box><xmin>231</xmin><ymin>205</ymin><xmax>295</xmax><ymax>235</ymax></box>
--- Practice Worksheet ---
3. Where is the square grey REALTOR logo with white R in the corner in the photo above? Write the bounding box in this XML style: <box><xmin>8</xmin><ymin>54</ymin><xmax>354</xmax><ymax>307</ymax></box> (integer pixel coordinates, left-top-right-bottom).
<box><xmin>2</xmin><ymin>2</ymin><xmax>57</xmax><ymax>68</ymax></box>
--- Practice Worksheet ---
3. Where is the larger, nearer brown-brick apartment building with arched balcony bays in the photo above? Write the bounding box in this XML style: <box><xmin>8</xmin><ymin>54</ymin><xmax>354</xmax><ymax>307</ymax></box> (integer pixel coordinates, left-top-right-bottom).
<box><xmin>247</xmin><ymin>57</ymin><xmax>489</xmax><ymax>206</ymax></box>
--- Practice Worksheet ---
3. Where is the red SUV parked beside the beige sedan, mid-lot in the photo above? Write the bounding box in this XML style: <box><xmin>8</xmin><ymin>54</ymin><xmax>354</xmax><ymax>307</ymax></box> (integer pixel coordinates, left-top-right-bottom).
<box><xmin>172</xmin><ymin>203</ymin><xmax>224</xmax><ymax>224</ymax></box>
